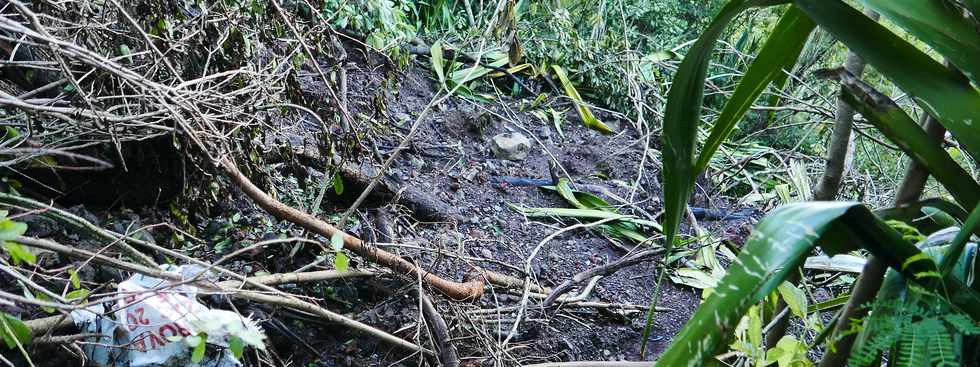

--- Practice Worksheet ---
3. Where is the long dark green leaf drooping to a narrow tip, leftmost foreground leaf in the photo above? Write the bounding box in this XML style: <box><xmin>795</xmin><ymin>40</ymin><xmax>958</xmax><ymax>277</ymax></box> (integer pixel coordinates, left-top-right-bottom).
<box><xmin>652</xmin><ymin>0</ymin><xmax>787</xmax><ymax>355</ymax></box>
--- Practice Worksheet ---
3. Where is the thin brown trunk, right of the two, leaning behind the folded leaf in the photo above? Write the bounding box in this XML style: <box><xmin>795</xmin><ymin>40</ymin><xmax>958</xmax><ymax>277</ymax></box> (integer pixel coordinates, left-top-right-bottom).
<box><xmin>820</xmin><ymin>113</ymin><xmax>946</xmax><ymax>367</ymax></box>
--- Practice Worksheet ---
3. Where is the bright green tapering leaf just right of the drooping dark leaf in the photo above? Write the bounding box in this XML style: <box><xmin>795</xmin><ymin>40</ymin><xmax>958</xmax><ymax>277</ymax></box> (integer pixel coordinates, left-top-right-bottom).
<box><xmin>692</xmin><ymin>6</ymin><xmax>815</xmax><ymax>174</ymax></box>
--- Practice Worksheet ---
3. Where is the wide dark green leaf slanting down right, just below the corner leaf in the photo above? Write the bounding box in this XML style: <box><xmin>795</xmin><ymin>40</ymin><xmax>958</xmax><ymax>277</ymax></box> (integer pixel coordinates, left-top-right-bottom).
<box><xmin>796</xmin><ymin>0</ymin><xmax>980</xmax><ymax>159</ymax></box>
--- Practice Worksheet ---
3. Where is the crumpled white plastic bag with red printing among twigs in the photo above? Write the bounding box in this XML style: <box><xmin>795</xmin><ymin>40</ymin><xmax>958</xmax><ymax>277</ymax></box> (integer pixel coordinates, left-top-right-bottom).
<box><xmin>71</xmin><ymin>265</ymin><xmax>264</xmax><ymax>367</ymax></box>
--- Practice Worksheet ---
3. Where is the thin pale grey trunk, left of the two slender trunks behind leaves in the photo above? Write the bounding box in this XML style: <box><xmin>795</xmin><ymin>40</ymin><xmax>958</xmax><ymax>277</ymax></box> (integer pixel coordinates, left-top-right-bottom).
<box><xmin>766</xmin><ymin>9</ymin><xmax>879</xmax><ymax>350</ymax></box>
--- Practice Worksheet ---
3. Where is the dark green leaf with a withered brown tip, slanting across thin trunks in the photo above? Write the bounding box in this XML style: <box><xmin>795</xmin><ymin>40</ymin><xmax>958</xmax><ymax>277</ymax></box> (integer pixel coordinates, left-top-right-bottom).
<box><xmin>817</xmin><ymin>69</ymin><xmax>980</xmax><ymax>208</ymax></box>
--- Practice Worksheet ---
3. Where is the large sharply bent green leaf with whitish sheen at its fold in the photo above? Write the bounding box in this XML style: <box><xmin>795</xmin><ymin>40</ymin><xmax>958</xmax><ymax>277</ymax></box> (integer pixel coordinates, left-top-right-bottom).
<box><xmin>657</xmin><ymin>202</ymin><xmax>980</xmax><ymax>366</ymax></box>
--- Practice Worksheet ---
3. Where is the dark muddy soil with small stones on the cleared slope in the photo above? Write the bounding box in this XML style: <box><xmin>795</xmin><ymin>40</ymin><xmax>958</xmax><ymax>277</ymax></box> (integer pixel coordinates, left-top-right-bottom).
<box><xmin>5</xmin><ymin>56</ymin><xmax>753</xmax><ymax>366</ymax></box>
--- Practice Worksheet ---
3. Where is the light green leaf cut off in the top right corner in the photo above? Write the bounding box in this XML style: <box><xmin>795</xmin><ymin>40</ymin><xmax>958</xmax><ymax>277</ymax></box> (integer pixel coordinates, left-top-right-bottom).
<box><xmin>861</xmin><ymin>0</ymin><xmax>980</xmax><ymax>83</ymax></box>
